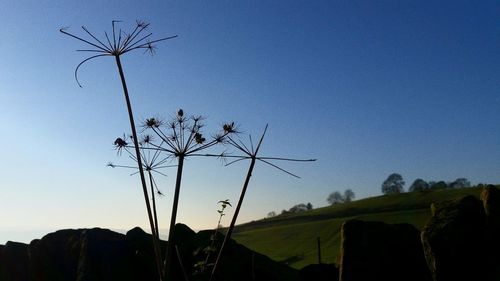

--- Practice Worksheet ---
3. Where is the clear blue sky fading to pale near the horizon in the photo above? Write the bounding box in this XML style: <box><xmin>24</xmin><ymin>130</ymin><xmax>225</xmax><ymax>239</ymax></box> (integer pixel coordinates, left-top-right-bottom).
<box><xmin>0</xmin><ymin>0</ymin><xmax>500</xmax><ymax>244</ymax></box>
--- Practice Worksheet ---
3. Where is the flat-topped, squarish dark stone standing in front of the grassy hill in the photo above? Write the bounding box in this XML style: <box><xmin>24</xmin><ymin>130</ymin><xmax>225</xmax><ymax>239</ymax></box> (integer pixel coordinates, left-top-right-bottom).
<box><xmin>340</xmin><ymin>220</ymin><xmax>431</xmax><ymax>281</ymax></box>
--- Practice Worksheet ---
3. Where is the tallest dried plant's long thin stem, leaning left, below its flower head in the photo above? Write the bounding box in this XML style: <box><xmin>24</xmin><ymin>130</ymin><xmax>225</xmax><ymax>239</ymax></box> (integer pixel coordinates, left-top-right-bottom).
<box><xmin>115</xmin><ymin>55</ymin><xmax>162</xmax><ymax>281</ymax></box>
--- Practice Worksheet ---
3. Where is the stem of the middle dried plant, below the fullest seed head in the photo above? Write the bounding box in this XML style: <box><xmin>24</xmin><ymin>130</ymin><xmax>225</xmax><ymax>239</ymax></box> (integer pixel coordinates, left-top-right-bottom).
<box><xmin>164</xmin><ymin>153</ymin><xmax>185</xmax><ymax>280</ymax></box>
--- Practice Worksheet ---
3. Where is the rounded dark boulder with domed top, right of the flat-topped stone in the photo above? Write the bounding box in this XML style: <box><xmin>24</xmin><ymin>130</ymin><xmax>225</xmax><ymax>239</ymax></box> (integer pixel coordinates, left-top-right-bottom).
<box><xmin>421</xmin><ymin>196</ymin><xmax>488</xmax><ymax>281</ymax></box>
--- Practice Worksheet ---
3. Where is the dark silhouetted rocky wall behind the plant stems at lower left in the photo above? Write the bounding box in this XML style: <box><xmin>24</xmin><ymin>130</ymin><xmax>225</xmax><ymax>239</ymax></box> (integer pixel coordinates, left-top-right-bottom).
<box><xmin>0</xmin><ymin>225</ymin><xmax>298</xmax><ymax>281</ymax></box>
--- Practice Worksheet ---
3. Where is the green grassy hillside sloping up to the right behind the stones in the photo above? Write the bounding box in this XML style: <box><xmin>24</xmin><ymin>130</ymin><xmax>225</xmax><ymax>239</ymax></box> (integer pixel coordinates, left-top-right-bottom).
<box><xmin>233</xmin><ymin>188</ymin><xmax>481</xmax><ymax>269</ymax></box>
